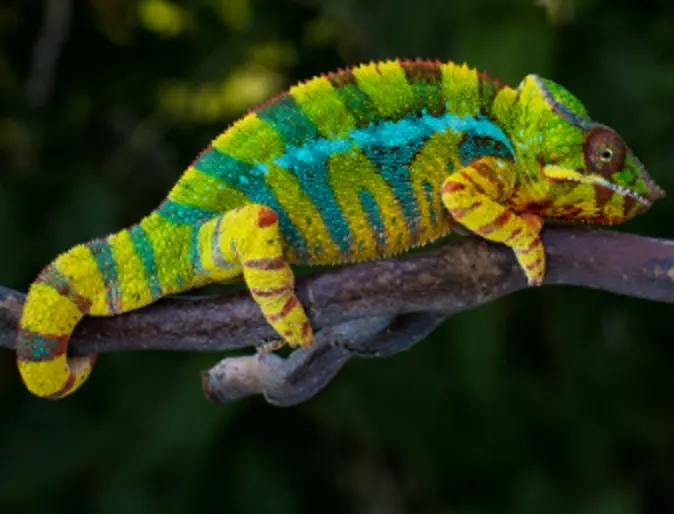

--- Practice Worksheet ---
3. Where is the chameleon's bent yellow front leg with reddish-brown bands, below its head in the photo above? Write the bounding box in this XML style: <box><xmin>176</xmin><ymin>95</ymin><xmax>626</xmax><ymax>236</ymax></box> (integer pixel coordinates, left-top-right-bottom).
<box><xmin>442</xmin><ymin>157</ymin><xmax>545</xmax><ymax>285</ymax></box>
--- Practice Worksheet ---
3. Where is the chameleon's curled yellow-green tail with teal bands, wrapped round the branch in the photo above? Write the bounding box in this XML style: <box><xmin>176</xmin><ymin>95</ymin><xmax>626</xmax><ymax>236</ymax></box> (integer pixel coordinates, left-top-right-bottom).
<box><xmin>17</xmin><ymin>207</ymin><xmax>213</xmax><ymax>399</ymax></box>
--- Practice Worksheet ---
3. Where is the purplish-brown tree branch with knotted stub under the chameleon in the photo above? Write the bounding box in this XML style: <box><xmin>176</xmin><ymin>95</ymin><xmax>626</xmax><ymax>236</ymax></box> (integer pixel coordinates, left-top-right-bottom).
<box><xmin>0</xmin><ymin>226</ymin><xmax>674</xmax><ymax>405</ymax></box>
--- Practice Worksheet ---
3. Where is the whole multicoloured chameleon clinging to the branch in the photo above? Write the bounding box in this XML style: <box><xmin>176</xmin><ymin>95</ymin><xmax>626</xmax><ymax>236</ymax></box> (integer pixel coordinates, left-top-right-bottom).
<box><xmin>17</xmin><ymin>60</ymin><xmax>664</xmax><ymax>398</ymax></box>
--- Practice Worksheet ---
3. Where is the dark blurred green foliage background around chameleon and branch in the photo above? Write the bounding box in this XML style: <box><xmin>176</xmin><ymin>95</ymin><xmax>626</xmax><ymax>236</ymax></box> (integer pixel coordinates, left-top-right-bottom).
<box><xmin>0</xmin><ymin>0</ymin><xmax>674</xmax><ymax>514</ymax></box>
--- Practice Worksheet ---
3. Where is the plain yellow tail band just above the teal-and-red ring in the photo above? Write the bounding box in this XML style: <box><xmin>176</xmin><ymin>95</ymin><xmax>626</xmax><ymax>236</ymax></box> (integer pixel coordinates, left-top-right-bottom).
<box><xmin>21</xmin><ymin>283</ymin><xmax>82</xmax><ymax>336</ymax></box>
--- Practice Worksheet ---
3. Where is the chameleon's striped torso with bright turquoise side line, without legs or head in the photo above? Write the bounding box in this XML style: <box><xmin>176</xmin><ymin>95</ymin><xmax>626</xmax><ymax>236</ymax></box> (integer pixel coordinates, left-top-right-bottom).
<box><xmin>161</xmin><ymin>61</ymin><xmax>514</xmax><ymax>264</ymax></box>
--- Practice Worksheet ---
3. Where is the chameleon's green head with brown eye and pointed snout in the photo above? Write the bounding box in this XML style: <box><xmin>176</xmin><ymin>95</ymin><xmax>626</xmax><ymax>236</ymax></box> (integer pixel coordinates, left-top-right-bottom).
<box><xmin>513</xmin><ymin>75</ymin><xmax>665</xmax><ymax>223</ymax></box>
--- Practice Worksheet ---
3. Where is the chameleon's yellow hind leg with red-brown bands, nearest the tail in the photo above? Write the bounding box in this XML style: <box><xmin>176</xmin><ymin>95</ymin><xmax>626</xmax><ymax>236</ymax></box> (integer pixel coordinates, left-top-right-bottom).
<box><xmin>199</xmin><ymin>204</ymin><xmax>313</xmax><ymax>347</ymax></box>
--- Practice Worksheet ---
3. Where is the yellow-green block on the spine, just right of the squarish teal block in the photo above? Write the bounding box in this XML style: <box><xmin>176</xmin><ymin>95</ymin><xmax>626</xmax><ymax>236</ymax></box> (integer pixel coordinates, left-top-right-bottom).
<box><xmin>290</xmin><ymin>77</ymin><xmax>356</xmax><ymax>138</ymax></box>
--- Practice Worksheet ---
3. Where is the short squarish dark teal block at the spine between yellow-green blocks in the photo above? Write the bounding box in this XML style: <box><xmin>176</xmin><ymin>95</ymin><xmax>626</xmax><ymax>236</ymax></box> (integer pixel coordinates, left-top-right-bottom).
<box><xmin>256</xmin><ymin>94</ymin><xmax>319</xmax><ymax>145</ymax></box>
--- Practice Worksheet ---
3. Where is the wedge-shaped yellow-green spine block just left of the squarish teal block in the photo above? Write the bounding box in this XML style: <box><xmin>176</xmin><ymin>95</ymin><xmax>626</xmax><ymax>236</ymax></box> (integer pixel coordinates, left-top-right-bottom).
<box><xmin>213</xmin><ymin>113</ymin><xmax>285</xmax><ymax>164</ymax></box>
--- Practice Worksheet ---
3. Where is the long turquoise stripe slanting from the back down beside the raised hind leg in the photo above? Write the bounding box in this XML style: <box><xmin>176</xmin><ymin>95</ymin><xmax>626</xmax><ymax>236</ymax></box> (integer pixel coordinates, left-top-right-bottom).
<box><xmin>194</xmin><ymin>148</ymin><xmax>310</xmax><ymax>260</ymax></box>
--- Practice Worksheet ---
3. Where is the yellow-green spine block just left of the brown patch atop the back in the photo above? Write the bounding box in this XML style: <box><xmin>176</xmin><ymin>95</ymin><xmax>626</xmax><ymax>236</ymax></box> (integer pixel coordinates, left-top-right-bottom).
<box><xmin>352</xmin><ymin>61</ymin><xmax>415</xmax><ymax>118</ymax></box>
